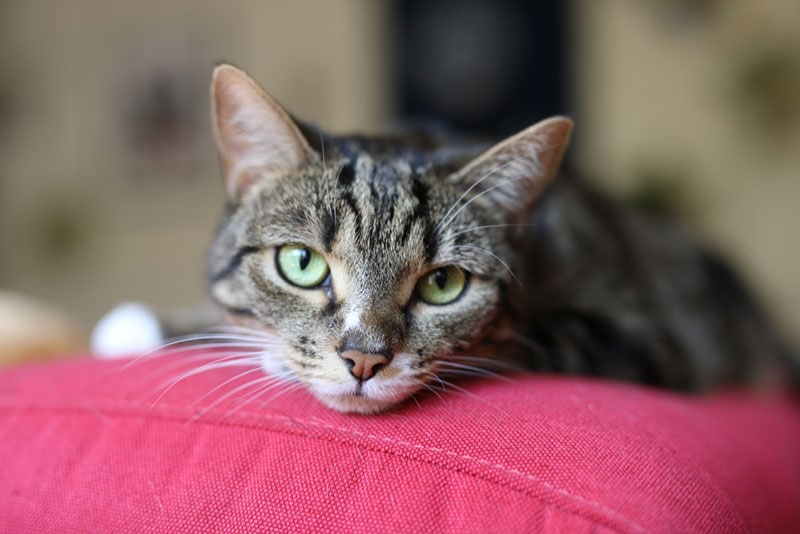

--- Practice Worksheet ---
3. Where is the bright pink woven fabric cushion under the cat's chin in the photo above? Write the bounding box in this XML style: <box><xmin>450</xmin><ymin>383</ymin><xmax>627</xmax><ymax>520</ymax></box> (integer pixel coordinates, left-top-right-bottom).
<box><xmin>0</xmin><ymin>356</ymin><xmax>800</xmax><ymax>533</ymax></box>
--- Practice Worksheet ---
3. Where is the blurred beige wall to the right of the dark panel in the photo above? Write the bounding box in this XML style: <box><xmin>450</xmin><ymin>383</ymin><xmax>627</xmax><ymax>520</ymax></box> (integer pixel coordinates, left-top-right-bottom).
<box><xmin>572</xmin><ymin>0</ymin><xmax>800</xmax><ymax>336</ymax></box>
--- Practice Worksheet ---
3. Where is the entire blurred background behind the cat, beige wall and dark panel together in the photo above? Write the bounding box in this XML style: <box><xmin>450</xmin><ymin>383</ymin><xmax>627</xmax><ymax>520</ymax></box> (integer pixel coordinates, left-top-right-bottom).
<box><xmin>0</xmin><ymin>0</ymin><xmax>800</xmax><ymax>344</ymax></box>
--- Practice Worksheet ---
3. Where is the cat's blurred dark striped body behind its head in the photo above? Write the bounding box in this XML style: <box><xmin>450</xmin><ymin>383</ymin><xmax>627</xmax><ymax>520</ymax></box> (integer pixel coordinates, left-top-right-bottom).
<box><xmin>525</xmin><ymin>171</ymin><xmax>786</xmax><ymax>390</ymax></box>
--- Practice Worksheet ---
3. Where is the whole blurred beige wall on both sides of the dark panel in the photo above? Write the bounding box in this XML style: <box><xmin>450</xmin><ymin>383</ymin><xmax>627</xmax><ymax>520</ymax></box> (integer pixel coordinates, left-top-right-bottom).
<box><xmin>0</xmin><ymin>0</ymin><xmax>800</xmax><ymax>344</ymax></box>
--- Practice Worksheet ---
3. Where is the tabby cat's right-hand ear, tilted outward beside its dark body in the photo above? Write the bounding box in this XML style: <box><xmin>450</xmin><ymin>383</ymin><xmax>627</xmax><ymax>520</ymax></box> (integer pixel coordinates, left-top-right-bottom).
<box><xmin>451</xmin><ymin>117</ymin><xmax>572</xmax><ymax>219</ymax></box>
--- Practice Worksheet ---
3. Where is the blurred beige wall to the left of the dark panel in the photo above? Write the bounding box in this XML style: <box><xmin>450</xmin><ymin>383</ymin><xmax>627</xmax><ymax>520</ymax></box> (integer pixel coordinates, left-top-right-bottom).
<box><xmin>0</xmin><ymin>0</ymin><xmax>389</xmax><ymax>326</ymax></box>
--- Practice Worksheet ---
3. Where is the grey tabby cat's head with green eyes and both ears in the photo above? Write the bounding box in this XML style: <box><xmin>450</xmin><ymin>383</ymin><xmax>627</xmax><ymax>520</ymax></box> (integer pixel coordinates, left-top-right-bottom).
<box><xmin>203</xmin><ymin>65</ymin><xmax>572</xmax><ymax>413</ymax></box>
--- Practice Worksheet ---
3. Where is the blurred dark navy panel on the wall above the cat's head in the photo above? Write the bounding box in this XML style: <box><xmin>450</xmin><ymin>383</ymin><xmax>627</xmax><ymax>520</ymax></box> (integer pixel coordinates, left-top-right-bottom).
<box><xmin>394</xmin><ymin>0</ymin><xmax>568</xmax><ymax>136</ymax></box>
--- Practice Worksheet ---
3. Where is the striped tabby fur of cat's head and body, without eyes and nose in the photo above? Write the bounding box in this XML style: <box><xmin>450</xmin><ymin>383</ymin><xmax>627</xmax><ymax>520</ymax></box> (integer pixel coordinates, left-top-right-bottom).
<box><xmin>208</xmin><ymin>65</ymin><xmax>782</xmax><ymax>412</ymax></box>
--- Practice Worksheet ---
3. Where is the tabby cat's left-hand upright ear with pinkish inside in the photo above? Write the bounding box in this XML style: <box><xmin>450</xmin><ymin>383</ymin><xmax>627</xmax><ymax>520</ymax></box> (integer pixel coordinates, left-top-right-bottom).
<box><xmin>211</xmin><ymin>65</ymin><xmax>316</xmax><ymax>202</ymax></box>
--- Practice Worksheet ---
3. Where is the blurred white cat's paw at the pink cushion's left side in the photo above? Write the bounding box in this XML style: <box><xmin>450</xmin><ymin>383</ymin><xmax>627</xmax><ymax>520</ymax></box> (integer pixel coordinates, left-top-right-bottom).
<box><xmin>91</xmin><ymin>302</ymin><xmax>164</xmax><ymax>358</ymax></box>
